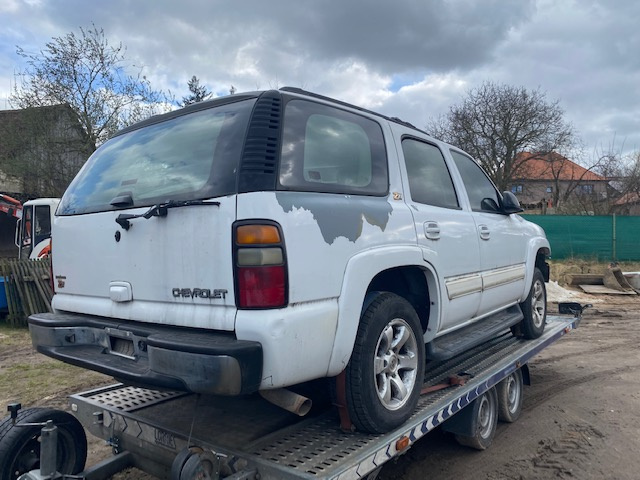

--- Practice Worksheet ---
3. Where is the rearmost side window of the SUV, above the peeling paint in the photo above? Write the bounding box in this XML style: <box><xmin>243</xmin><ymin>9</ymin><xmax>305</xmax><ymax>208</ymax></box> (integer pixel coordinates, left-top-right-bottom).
<box><xmin>279</xmin><ymin>100</ymin><xmax>388</xmax><ymax>195</ymax></box>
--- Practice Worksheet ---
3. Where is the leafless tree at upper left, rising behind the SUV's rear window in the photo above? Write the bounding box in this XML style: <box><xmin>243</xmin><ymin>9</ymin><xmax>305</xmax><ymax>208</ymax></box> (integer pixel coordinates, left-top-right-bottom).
<box><xmin>10</xmin><ymin>25</ymin><xmax>170</xmax><ymax>152</ymax></box>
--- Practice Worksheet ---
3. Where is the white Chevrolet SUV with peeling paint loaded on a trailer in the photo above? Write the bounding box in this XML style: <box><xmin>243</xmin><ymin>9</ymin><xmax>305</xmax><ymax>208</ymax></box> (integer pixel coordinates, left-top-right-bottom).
<box><xmin>29</xmin><ymin>88</ymin><xmax>549</xmax><ymax>432</ymax></box>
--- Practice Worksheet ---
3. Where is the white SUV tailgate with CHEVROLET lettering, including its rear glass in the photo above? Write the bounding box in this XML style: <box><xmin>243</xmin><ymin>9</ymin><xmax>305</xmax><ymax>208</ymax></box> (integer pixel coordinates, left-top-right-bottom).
<box><xmin>53</xmin><ymin>99</ymin><xmax>253</xmax><ymax>330</ymax></box>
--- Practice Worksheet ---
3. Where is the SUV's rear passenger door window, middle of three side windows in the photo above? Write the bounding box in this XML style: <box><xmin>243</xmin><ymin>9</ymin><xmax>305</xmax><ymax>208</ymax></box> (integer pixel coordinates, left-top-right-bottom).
<box><xmin>402</xmin><ymin>138</ymin><xmax>459</xmax><ymax>208</ymax></box>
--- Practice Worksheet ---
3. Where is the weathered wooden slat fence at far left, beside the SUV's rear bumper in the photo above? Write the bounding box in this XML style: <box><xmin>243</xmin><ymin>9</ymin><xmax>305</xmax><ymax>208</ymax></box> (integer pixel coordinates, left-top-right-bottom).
<box><xmin>0</xmin><ymin>259</ymin><xmax>53</xmax><ymax>326</ymax></box>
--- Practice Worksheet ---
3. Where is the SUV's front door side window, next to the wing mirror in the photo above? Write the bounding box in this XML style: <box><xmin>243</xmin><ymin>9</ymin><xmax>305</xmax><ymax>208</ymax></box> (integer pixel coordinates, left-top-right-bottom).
<box><xmin>451</xmin><ymin>150</ymin><xmax>500</xmax><ymax>212</ymax></box>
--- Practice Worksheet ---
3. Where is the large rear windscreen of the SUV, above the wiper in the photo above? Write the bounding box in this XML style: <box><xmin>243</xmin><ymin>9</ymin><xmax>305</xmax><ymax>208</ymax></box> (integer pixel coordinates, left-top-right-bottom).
<box><xmin>57</xmin><ymin>99</ymin><xmax>255</xmax><ymax>215</ymax></box>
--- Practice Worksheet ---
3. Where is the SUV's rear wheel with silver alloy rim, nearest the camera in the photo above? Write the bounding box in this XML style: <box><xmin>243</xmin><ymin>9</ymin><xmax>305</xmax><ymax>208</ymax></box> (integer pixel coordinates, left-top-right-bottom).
<box><xmin>346</xmin><ymin>292</ymin><xmax>425</xmax><ymax>433</ymax></box>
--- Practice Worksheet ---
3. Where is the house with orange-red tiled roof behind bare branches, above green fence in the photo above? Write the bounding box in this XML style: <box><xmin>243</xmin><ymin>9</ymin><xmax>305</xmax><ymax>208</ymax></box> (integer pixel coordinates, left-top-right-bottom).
<box><xmin>509</xmin><ymin>152</ymin><xmax>609</xmax><ymax>210</ymax></box>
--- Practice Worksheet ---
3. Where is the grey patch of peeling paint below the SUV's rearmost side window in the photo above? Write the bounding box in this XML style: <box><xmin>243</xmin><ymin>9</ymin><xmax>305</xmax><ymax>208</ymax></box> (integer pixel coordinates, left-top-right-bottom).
<box><xmin>276</xmin><ymin>192</ymin><xmax>392</xmax><ymax>245</ymax></box>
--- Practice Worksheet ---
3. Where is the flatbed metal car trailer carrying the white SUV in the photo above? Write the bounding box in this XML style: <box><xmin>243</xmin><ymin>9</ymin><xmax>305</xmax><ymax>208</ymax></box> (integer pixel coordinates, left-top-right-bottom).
<box><xmin>0</xmin><ymin>303</ymin><xmax>586</xmax><ymax>480</ymax></box>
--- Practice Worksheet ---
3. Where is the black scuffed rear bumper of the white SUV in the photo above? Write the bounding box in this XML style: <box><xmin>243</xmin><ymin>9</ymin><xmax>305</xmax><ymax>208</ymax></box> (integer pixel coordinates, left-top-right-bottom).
<box><xmin>29</xmin><ymin>313</ymin><xmax>263</xmax><ymax>395</ymax></box>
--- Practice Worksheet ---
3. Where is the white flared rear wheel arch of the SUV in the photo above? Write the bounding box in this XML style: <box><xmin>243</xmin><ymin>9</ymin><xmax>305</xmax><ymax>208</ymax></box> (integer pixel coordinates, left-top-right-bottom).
<box><xmin>327</xmin><ymin>247</ymin><xmax>439</xmax><ymax>376</ymax></box>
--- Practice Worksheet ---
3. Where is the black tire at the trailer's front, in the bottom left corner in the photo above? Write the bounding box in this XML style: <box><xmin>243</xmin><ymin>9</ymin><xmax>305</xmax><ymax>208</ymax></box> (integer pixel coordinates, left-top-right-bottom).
<box><xmin>0</xmin><ymin>408</ymin><xmax>87</xmax><ymax>480</ymax></box>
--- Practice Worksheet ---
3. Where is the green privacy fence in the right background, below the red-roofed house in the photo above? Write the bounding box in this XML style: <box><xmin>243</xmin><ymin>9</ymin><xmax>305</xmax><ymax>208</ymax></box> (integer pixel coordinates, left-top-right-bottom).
<box><xmin>523</xmin><ymin>215</ymin><xmax>640</xmax><ymax>261</ymax></box>
